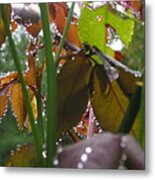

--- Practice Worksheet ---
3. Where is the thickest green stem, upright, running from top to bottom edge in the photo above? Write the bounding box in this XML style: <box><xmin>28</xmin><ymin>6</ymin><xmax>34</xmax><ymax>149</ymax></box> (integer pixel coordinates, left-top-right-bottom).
<box><xmin>39</xmin><ymin>3</ymin><xmax>57</xmax><ymax>167</ymax></box>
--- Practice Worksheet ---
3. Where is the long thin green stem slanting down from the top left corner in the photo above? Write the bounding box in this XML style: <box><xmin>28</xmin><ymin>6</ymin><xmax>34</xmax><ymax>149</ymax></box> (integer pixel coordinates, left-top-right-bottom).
<box><xmin>3</xmin><ymin>5</ymin><xmax>42</xmax><ymax>164</ymax></box>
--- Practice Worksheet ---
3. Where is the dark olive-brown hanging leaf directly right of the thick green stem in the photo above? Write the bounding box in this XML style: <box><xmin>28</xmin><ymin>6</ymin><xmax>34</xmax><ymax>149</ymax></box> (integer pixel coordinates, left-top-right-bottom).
<box><xmin>57</xmin><ymin>55</ymin><xmax>92</xmax><ymax>136</ymax></box>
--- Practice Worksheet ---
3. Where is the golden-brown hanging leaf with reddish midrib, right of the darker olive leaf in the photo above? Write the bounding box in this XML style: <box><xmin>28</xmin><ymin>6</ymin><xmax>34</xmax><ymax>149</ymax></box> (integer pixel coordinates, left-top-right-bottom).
<box><xmin>91</xmin><ymin>65</ymin><xmax>128</xmax><ymax>132</ymax></box>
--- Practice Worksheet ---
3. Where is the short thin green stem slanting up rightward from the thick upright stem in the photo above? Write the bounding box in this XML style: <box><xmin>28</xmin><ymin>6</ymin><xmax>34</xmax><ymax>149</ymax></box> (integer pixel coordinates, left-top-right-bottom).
<box><xmin>55</xmin><ymin>2</ymin><xmax>75</xmax><ymax>62</ymax></box>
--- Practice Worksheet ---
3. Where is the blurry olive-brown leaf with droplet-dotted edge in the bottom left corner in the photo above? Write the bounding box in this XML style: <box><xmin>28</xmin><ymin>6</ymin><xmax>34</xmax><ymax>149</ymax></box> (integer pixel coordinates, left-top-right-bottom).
<box><xmin>6</xmin><ymin>144</ymin><xmax>39</xmax><ymax>167</ymax></box>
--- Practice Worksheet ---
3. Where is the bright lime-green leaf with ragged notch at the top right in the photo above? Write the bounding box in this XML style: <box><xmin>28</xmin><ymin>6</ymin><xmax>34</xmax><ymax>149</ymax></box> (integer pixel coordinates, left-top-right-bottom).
<box><xmin>79</xmin><ymin>5</ymin><xmax>134</xmax><ymax>57</ymax></box>
